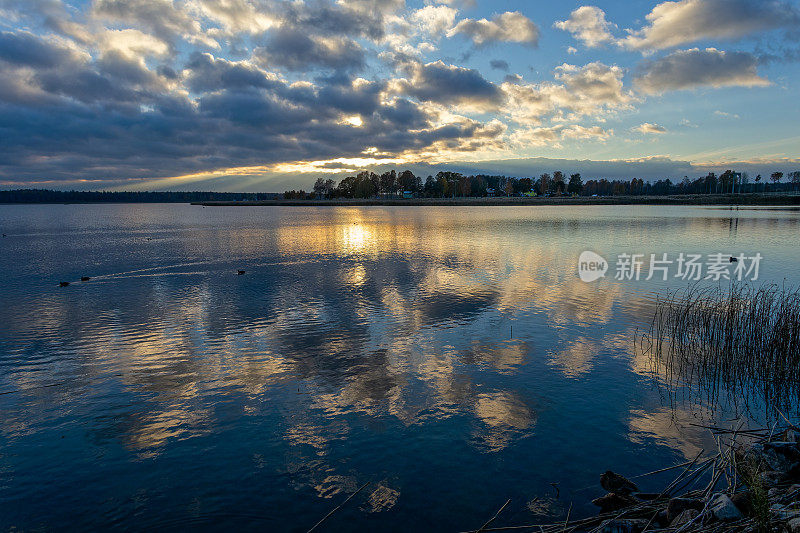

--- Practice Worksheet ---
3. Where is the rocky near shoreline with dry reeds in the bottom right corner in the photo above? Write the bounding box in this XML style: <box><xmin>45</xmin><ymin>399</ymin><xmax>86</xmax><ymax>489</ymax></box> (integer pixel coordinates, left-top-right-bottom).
<box><xmin>476</xmin><ymin>420</ymin><xmax>800</xmax><ymax>533</ymax></box>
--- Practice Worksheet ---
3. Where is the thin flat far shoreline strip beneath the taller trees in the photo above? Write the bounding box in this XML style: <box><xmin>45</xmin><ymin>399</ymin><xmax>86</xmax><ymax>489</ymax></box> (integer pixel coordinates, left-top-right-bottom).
<box><xmin>191</xmin><ymin>194</ymin><xmax>800</xmax><ymax>207</ymax></box>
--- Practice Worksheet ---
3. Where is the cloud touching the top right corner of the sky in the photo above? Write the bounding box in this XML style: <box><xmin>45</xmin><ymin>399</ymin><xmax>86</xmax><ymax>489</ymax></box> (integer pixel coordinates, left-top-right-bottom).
<box><xmin>619</xmin><ymin>0</ymin><xmax>800</xmax><ymax>50</ymax></box>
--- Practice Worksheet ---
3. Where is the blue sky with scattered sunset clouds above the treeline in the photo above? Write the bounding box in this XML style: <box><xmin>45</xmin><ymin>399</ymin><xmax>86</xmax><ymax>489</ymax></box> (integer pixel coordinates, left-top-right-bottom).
<box><xmin>0</xmin><ymin>0</ymin><xmax>800</xmax><ymax>192</ymax></box>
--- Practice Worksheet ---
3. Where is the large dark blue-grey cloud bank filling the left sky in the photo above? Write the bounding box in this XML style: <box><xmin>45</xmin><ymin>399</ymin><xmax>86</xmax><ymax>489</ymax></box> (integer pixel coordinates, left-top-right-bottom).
<box><xmin>0</xmin><ymin>26</ymin><xmax>501</xmax><ymax>182</ymax></box>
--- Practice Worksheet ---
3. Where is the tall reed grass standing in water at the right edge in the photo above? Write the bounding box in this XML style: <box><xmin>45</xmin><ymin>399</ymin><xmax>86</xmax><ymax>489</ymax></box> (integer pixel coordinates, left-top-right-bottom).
<box><xmin>639</xmin><ymin>284</ymin><xmax>800</xmax><ymax>415</ymax></box>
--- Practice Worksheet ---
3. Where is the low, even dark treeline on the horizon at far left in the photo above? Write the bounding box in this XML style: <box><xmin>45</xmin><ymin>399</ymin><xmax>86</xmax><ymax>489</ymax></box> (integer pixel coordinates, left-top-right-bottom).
<box><xmin>0</xmin><ymin>189</ymin><xmax>281</xmax><ymax>204</ymax></box>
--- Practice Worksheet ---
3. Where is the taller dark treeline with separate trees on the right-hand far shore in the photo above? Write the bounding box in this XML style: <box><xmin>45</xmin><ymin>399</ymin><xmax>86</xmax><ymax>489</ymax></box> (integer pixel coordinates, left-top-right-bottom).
<box><xmin>283</xmin><ymin>170</ymin><xmax>800</xmax><ymax>200</ymax></box>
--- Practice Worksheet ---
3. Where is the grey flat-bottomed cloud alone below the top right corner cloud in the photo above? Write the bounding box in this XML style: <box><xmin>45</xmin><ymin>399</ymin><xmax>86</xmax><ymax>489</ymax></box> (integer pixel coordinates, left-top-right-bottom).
<box><xmin>634</xmin><ymin>48</ymin><xmax>770</xmax><ymax>94</ymax></box>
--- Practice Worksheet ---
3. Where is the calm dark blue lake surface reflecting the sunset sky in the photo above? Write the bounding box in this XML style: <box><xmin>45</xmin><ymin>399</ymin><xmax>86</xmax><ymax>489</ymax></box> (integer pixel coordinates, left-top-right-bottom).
<box><xmin>0</xmin><ymin>205</ymin><xmax>800</xmax><ymax>531</ymax></box>
